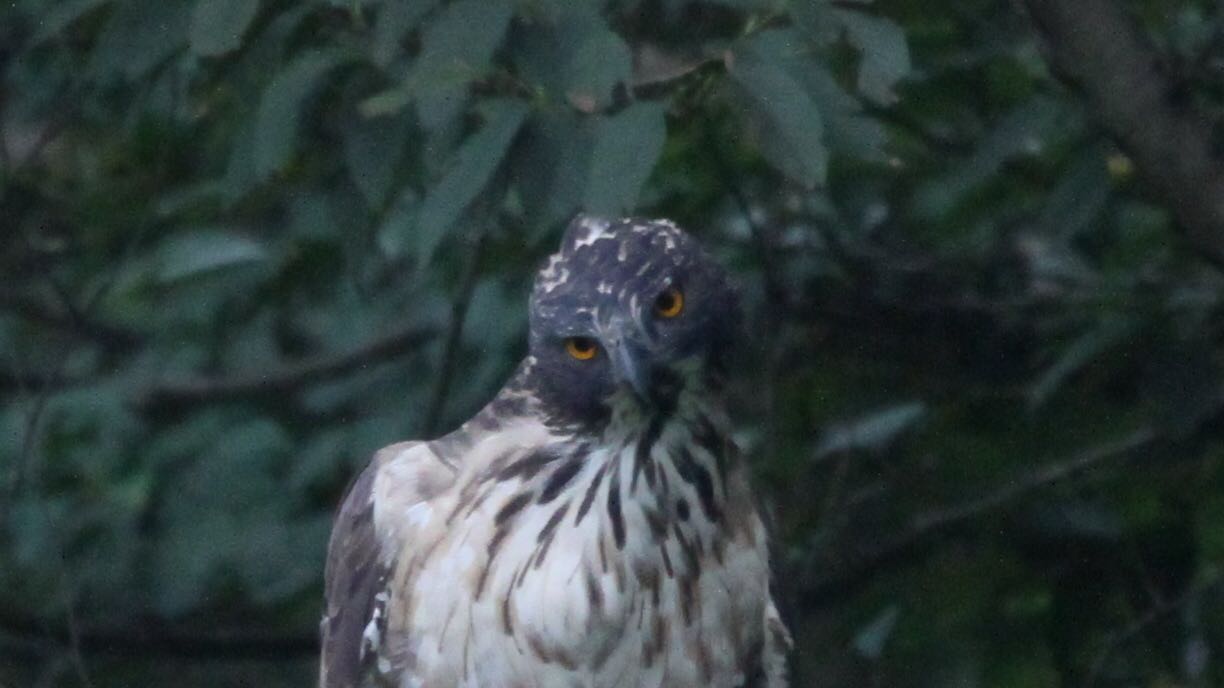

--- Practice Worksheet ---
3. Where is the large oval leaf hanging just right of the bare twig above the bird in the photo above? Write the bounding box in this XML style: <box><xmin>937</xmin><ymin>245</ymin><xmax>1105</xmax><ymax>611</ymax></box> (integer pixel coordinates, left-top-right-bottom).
<box><xmin>731</xmin><ymin>33</ymin><xmax>829</xmax><ymax>189</ymax></box>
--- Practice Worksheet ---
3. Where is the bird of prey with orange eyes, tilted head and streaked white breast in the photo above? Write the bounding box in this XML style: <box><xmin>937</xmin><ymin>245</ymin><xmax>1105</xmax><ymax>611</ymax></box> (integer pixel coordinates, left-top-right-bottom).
<box><xmin>319</xmin><ymin>215</ymin><xmax>791</xmax><ymax>688</ymax></box>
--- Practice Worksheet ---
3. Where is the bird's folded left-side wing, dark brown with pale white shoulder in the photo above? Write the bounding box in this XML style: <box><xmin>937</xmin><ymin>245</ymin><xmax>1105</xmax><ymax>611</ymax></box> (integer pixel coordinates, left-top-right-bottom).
<box><xmin>319</xmin><ymin>442</ymin><xmax>454</xmax><ymax>688</ymax></box>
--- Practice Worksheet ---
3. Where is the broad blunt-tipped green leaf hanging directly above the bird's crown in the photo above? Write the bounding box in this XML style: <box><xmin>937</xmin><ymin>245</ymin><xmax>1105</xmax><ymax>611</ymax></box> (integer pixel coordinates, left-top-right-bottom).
<box><xmin>583</xmin><ymin>103</ymin><xmax>667</xmax><ymax>214</ymax></box>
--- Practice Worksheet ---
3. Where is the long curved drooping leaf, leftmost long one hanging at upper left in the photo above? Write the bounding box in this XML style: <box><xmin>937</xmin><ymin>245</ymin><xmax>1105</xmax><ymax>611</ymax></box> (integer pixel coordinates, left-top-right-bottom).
<box><xmin>253</xmin><ymin>51</ymin><xmax>343</xmax><ymax>179</ymax></box>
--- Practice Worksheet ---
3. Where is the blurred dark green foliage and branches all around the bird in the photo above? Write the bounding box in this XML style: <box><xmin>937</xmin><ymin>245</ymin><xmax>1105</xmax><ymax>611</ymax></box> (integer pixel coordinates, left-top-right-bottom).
<box><xmin>7</xmin><ymin>0</ymin><xmax>1224</xmax><ymax>687</ymax></box>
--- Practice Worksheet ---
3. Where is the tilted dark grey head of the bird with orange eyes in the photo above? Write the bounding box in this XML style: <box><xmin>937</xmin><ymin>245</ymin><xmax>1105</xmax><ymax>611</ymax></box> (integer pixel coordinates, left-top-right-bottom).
<box><xmin>530</xmin><ymin>215</ymin><xmax>739</xmax><ymax>420</ymax></box>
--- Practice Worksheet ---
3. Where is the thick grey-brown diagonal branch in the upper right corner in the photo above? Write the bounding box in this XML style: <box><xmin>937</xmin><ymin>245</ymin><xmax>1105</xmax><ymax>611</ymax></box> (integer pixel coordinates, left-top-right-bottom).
<box><xmin>1017</xmin><ymin>0</ymin><xmax>1224</xmax><ymax>267</ymax></box>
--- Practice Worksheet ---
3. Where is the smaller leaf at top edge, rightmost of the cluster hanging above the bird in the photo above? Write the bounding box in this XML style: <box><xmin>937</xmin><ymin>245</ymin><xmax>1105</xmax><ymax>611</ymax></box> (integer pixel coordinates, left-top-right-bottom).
<box><xmin>835</xmin><ymin>10</ymin><xmax>911</xmax><ymax>105</ymax></box>
